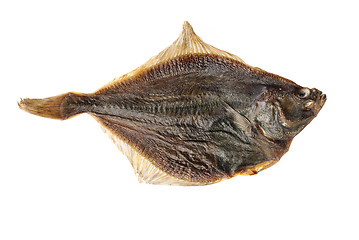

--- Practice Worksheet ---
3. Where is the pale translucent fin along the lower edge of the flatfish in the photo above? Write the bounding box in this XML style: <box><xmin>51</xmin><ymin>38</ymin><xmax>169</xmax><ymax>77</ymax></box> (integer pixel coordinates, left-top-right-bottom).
<box><xmin>93</xmin><ymin>116</ymin><xmax>219</xmax><ymax>186</ymax></box>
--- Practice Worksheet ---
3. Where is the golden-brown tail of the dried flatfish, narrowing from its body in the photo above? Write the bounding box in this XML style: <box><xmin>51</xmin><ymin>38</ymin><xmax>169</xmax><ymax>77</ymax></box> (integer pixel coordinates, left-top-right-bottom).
<box><xmin>18</xmin><ymin>92</ymin><xmax>85</xmax><ymax>120</ymax></box>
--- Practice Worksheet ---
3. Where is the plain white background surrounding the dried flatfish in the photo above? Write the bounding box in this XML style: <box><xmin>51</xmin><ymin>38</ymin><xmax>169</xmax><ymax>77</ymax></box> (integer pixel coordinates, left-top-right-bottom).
<box><xmin>0</xmin><ymin>0</ymin><xmax>359</xmax><ymax>240</ymax></box>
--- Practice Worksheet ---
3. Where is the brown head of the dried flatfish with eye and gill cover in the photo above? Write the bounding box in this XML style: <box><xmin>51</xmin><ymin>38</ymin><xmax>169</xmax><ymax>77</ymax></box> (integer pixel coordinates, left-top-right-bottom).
<box><xmin>252</xmin><ymin>84</ymin><xmax>326</xmax><ymax>140</ymax></box>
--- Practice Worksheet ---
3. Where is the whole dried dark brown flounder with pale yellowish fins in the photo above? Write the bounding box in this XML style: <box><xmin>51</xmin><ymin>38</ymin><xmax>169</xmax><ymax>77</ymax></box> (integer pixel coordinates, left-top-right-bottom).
<box><xmin>19</xmin><ymin>22</ymin><xmax>326</xmax><ymax>185</ymax></box>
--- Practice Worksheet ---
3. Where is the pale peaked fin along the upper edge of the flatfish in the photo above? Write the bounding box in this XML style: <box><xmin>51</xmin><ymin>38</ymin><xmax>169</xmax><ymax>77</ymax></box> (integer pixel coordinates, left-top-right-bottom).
<box><xmin>95</xmin><ymin>21</ymin><xmax>247</xmax><ymax>90</ymax></box>
